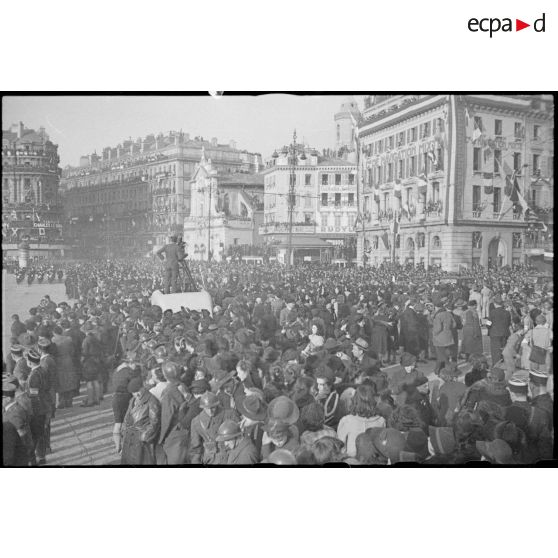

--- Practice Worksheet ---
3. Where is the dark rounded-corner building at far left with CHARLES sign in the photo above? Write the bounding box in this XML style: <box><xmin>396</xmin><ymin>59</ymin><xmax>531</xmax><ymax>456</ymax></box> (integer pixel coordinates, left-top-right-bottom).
<box><xmin>2</xmin><ymin>122</ymin><xmax>68</xmax><ymax>258</ymax></box>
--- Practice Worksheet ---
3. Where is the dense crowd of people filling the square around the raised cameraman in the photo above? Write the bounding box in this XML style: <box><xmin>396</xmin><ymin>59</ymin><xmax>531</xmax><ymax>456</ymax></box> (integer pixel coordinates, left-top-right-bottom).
<box><xmin>2</xmin><ymin>252</ymin><xmax>554</xmax><ymax>465</ymax></box>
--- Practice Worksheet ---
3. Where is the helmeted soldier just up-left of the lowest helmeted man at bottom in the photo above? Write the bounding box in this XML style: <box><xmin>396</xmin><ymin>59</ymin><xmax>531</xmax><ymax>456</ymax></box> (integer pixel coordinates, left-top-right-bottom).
<box><xmin>189</xmin><ymin>392</ymin><xmax>239</xmax><ymax>465</ymax></box>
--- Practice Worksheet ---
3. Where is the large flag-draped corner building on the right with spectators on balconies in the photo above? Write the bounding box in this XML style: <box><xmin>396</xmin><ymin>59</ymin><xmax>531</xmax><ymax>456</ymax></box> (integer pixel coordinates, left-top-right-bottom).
<box><xmin>358</xmin><ymin>95</ymin><xmax>554</xmax><ymax>271</ymax></box>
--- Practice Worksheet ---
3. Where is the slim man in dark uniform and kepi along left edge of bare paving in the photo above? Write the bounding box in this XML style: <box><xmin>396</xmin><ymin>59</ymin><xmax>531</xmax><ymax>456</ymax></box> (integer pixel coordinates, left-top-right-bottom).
<box><xmin>26</xmin><ymin>349</ymin><xmax>50</xmax><ymax>465</ymax></box>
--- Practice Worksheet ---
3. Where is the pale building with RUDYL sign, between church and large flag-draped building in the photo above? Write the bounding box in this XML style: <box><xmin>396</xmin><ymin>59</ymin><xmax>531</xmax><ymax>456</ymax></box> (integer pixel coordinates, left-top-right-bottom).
<box><xmin>260</xmin><ymin>137</ymin><xmax>357</xmax><ymax>263</ymax></box>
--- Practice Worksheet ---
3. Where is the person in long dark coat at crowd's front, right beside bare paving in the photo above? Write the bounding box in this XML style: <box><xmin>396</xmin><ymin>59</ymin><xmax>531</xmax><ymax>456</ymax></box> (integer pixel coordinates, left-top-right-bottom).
<box><xmin>121</xmin><ymin>376</ymin><xmax>161</xmax><ymax>465</ymax></box>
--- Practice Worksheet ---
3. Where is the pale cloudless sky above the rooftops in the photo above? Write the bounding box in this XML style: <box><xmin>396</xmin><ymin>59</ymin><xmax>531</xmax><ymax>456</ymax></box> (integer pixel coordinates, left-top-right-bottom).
<box><xmin>2</xmin><ymin>92</ymin><xmax>362</xmax><ymax>167</ymax></box>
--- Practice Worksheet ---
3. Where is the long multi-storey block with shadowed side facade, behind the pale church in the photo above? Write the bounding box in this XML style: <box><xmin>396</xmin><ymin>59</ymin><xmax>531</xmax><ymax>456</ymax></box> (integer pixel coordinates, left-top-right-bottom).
<box><xmin>62</xmin><ymin>132</ymin><xmax>261</xmax><ymax>255</ymax></box>
